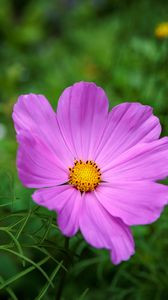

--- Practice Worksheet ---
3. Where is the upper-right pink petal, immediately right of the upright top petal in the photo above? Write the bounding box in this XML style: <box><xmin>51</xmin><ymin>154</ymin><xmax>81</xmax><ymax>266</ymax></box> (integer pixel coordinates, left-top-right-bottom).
<box><xmin>95</xmin><ymin>103</ymin><xmax>161</xmax><ymax>165</ymax></box>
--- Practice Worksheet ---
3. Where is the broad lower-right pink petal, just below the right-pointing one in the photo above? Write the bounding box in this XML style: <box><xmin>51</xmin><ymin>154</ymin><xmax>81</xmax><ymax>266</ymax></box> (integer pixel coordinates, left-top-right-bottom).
<box><xmin>95</xmin><ymin>181</ymin><xmax>168</xmax><ymax>225</ymax></box>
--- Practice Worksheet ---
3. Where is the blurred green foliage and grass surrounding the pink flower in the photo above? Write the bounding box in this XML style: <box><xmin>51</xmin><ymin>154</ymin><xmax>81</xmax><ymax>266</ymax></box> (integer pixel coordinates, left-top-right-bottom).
<box><xmin>0</xmin><ymin>0</ymin><xmax>168</xmax><ymax>300</ymax></box>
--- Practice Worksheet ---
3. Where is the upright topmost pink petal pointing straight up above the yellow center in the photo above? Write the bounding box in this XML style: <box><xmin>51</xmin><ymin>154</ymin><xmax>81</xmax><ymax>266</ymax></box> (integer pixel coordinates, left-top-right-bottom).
<box><xmin>57</xmin><ymin>82</ymin><xmax>108</xmax><ymax>160</ymax></box>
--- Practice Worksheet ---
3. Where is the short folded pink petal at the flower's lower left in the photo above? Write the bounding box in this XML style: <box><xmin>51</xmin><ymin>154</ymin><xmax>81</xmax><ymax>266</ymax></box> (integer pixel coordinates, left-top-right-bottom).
<box><xmin>32</xmin><ymin>185</ymin><xmax>82</xmax><ymax>236</ymax></box>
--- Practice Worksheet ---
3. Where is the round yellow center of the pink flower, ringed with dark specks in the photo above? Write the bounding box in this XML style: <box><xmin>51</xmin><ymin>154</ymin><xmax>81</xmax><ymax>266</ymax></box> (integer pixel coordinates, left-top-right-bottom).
<box><xmin>69</xmin><ymin>160</ymin><xmax>101</xmax><ymax>192</ymax></box>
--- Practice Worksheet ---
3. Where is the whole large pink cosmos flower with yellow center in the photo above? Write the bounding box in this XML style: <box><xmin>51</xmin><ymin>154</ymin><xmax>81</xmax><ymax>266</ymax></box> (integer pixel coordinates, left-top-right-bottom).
<box><xmin>13</xmin><ymin>82</ymin><xmax>168</xmax><ymax>264</ymax></box>
